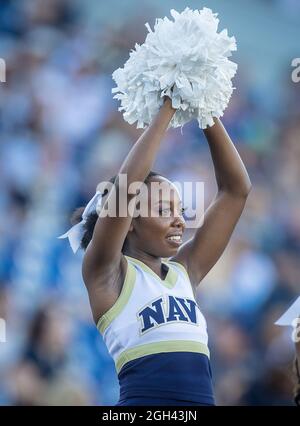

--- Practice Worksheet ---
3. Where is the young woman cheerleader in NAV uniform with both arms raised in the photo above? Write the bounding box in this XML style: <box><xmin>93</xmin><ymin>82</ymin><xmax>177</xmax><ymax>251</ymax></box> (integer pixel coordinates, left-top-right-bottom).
<box><xmin>69</xmin><ymin>97</ymin><xmax>251</xmax><ymax>405</ymax></box>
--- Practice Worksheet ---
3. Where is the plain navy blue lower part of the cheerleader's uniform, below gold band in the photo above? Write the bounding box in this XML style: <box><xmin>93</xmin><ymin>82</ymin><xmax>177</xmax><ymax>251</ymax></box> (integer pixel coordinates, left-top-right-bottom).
<box><xmin>116</xmin><ymin>352</ymin><xmax>215</xmax><ymax>406</ymax></box>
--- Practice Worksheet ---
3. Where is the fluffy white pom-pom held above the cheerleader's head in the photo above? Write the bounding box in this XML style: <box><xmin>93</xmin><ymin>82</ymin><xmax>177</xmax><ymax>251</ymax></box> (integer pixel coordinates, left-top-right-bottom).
<box><xmin>112</xmin><ymin>8</ymin><xmax>237</xmax><ymax>129</ymax></box>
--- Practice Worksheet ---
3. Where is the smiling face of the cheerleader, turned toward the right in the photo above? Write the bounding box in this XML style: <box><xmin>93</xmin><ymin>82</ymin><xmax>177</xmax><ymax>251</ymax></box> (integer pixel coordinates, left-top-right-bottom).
<box><xmin>127</xmin><ymin>176</ymin><xmax>185</xmax><ymax>258</ymax></box>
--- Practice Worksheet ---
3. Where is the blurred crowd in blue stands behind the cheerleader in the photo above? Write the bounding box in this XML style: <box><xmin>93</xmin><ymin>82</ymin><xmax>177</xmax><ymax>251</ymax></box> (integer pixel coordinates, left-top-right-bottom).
<box><xmin>0</xmin><ymin>0</ymin><xmax>300</xmax><ymax>405</ymax></box>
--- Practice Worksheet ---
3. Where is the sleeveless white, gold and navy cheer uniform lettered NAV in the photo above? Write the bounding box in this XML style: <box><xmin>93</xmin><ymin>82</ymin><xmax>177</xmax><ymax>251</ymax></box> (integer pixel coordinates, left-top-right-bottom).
<box><xmin>97</xmin><ymin>256</ymin><xmax>214</xmax><ymax>405</ymax></box>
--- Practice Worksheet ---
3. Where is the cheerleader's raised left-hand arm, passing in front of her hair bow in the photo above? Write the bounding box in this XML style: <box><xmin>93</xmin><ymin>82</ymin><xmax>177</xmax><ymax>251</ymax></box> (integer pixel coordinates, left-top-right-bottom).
<box><xmin>82</xmin><ymin>98</ymin><xmax>176</xmax><ymax>282</ymax></box>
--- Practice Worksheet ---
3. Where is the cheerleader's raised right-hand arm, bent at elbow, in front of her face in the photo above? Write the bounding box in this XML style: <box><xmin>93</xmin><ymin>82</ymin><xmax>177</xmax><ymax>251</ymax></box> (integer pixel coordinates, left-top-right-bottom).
<box><xmin>174</xmin><ymin>118</ymin><xmax>251</xmax><ymax>287</ymax></box>
